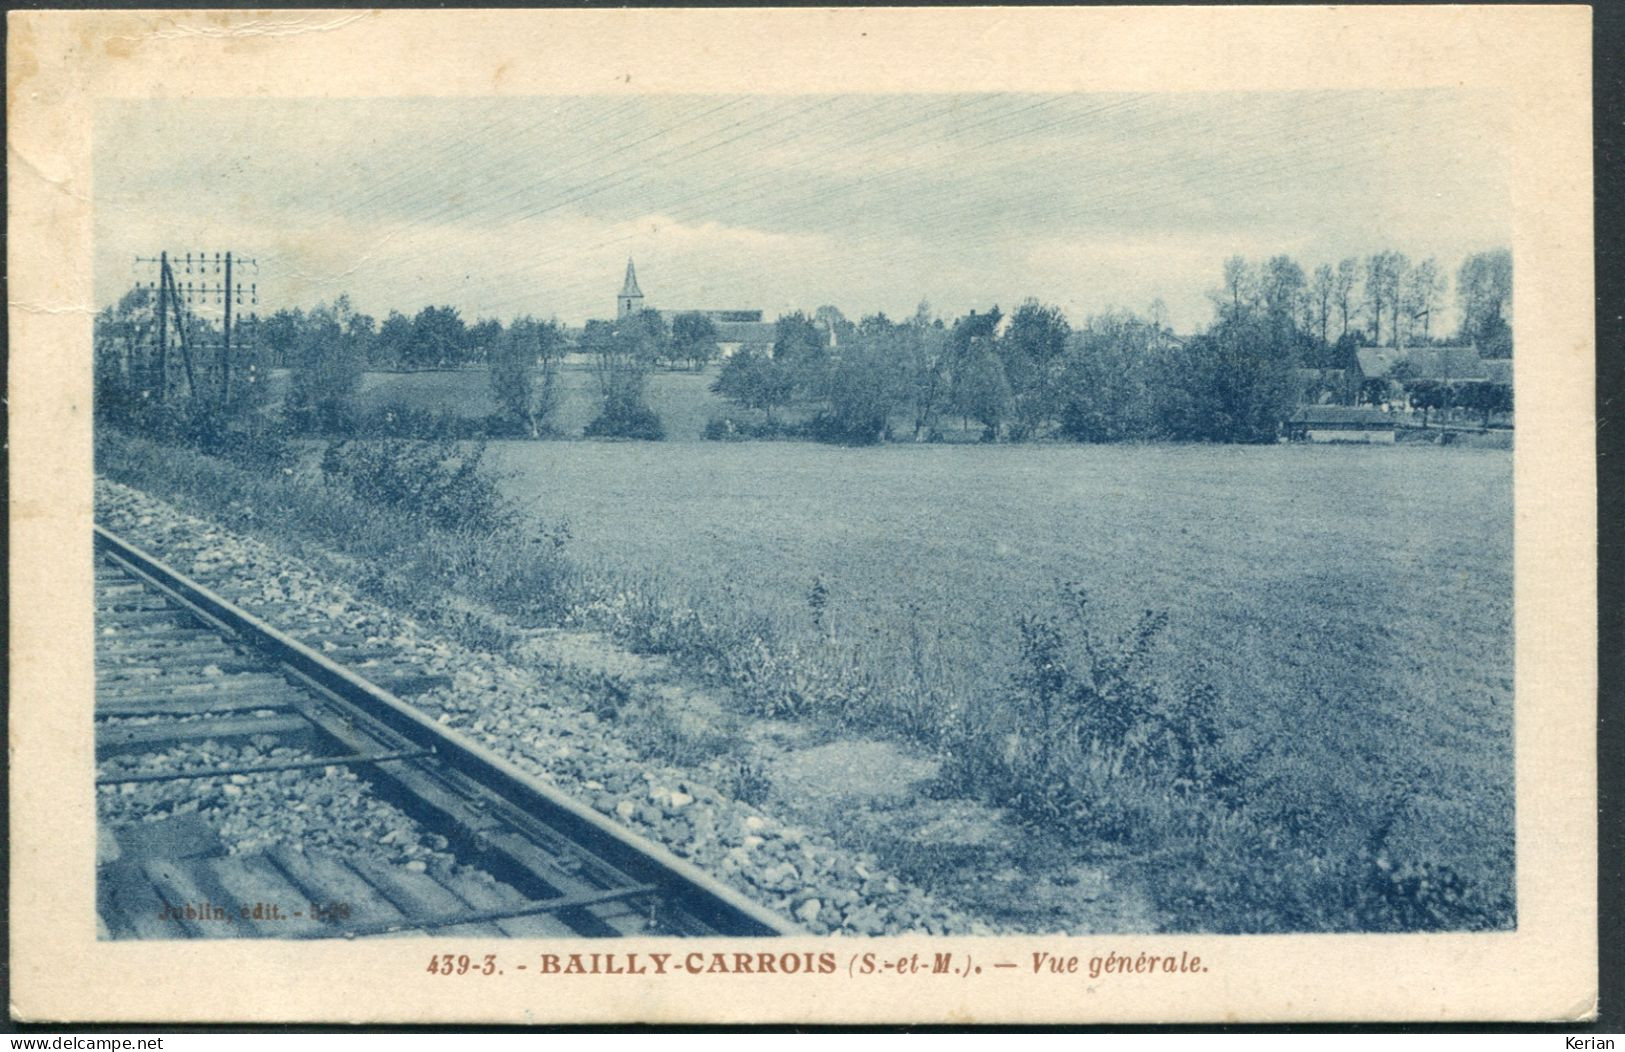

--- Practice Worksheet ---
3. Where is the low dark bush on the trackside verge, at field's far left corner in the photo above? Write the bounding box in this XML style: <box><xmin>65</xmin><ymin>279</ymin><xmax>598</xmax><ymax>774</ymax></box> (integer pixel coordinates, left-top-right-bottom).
<box><xmin>322</xmin><ymin>441</ymin><xmax>517</xmax><ymax>533</ymax></box>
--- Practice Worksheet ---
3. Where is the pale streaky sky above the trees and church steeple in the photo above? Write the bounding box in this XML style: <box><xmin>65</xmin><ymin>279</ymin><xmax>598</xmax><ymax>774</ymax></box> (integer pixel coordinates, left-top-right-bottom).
<box><xmin>93</xmin><ymin>89</ymin><xmax>1511</xmax><ymax>332</ymax></box>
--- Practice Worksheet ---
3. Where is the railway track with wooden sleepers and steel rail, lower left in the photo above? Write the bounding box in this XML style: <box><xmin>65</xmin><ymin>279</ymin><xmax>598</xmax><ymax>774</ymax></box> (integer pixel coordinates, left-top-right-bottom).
<box><xmin>96</xmin><ymin>527</ymin><xmax>795</xmax><ymax>938</ymax></box>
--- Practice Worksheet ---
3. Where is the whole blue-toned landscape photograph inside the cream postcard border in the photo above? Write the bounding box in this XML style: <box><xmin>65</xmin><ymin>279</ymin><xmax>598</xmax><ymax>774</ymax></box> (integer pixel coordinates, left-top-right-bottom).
<box><xmin>91</xmin><ymin>88</ymin><xmax>1508</xmax><ymax>943</ymax></box>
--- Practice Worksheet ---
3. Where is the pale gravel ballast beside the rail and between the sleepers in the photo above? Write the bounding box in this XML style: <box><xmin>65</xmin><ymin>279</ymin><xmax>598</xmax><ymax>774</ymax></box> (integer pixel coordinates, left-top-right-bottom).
<box><xmin>96</xmin><ymin>480</ymin><xmax>996</xmax><ymax>935</ymax></box>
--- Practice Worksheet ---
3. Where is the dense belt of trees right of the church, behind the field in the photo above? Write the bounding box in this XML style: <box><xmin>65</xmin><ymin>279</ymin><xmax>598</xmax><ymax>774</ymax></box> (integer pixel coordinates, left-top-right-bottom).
<box><xmin>712</xmin><ymin>250</ymin><xmax>1511</xmax><ymax>444</ymax></box>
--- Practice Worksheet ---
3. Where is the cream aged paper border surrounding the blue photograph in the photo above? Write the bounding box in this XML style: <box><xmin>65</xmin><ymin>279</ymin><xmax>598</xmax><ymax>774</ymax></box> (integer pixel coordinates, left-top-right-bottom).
<box><xmin>7</xmin><ymin>7</ymin><xmax>1597</xmax><ymax>1023</ymax></box>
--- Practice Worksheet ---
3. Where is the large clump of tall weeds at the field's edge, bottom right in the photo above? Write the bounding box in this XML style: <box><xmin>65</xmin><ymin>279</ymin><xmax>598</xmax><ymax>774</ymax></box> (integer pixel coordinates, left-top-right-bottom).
<box><xmin>943</xmin><ymin>585</ymin><xmax>1513</xmax><ymax>933</ymax></box>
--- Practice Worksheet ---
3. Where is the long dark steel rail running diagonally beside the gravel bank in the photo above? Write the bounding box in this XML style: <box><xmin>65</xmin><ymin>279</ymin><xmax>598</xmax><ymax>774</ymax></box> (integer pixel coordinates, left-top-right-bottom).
<box><xmin>94</xmin><ymin>524</ymin><xmax>803</xmax><ymax>937</ymax></box>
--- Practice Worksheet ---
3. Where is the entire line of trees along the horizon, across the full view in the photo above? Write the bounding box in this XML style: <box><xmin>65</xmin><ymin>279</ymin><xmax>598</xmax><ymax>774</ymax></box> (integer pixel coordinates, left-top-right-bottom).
<box><xmin>96</xmin><ymin>250</ymin><xmax>1511</xmax><ymax>444</ymax></box>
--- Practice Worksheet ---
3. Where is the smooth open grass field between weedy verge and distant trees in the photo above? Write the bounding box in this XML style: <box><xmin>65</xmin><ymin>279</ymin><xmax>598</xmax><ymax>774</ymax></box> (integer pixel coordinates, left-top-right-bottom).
<box><xmin>492</xmin><ymin>442</ymin><xmax>1513</xmax><ymax>910</ymax></box>
